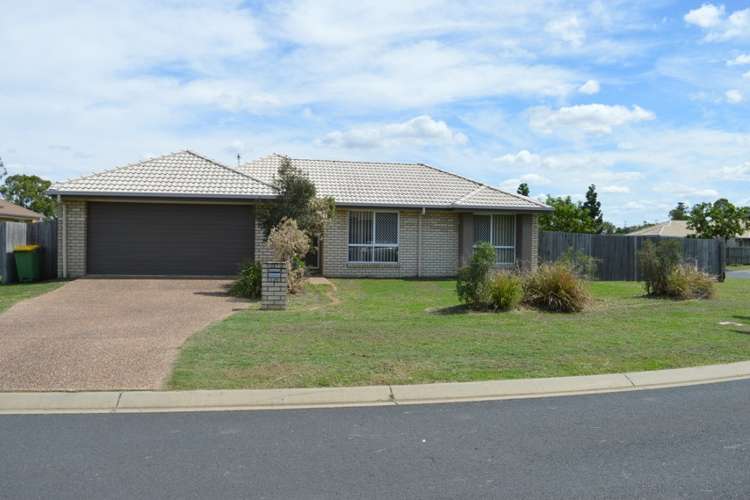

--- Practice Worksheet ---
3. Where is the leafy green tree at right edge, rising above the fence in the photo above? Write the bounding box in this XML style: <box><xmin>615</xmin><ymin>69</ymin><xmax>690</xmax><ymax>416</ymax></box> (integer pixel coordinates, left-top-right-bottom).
<box><xmin>687</xmin><ymin>198</ymin><xmax>750</xmax><ymax>240</ymax></box>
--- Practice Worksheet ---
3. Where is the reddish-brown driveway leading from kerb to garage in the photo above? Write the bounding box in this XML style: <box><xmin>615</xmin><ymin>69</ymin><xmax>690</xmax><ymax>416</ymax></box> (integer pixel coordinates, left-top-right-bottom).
<box><xmin>0</xmin><ymin>279</ymin><xmax>247</xmax><ymax>391</ymax></box>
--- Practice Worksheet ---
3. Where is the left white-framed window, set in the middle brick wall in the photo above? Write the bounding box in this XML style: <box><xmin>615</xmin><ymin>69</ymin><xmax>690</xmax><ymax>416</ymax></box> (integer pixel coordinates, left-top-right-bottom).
<box><xmin>349</xmin><ymin>210</ymin><xmax>399</xmax><ymax>262</ymax></box>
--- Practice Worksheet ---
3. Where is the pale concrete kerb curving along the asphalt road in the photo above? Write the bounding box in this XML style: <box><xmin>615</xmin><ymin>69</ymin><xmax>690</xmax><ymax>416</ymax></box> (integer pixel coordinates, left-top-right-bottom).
<box><xmin>0</xmin><ymin>361</ymin><xmax>750</xmax><ymax>414</ymax></box>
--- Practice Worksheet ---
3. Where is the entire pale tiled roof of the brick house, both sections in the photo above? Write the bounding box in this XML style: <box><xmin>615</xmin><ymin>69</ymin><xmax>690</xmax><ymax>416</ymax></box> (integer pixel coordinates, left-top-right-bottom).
<box><xmin>50</xmin><ymin>151</ymin><xmax>550</xmax><ymax>210</ymax></box>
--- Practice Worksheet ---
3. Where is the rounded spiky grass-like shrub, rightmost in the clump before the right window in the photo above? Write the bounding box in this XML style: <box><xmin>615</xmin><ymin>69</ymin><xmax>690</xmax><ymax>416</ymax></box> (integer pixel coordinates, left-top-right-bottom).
<box><xmin>523</xmin><ymin>263</ymin><xmax>590</xmax><ymax>312</ymax></box>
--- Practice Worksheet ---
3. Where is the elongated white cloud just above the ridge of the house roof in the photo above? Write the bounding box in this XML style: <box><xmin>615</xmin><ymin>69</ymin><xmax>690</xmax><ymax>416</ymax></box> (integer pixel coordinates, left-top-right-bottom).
<box><xmin>321</xmin><ymin>115</ymin><xmax>468</xmax><ymax>148</ymax></box>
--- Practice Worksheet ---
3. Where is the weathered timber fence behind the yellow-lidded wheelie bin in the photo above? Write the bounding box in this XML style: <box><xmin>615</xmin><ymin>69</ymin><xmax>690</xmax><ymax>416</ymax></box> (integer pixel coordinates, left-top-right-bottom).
<box><xmin>0</xmin><ymin>221</ymin><xmax>57</xmax><ymax>284</ymax></box>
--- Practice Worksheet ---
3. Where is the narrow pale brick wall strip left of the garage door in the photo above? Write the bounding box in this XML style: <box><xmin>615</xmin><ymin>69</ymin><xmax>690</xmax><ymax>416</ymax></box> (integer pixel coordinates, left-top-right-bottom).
<box><xmin>57</xmin><ymin>201</ymin><xmax>86</xmax><ymax>278</ymax></box>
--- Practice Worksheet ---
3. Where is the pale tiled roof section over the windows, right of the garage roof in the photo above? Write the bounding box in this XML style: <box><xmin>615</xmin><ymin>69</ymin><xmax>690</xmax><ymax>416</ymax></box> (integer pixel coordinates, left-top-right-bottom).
<box><xmin>238</xmin><ymin>154</ymin><xmax>548</xmax><ymax>210</ymax></box>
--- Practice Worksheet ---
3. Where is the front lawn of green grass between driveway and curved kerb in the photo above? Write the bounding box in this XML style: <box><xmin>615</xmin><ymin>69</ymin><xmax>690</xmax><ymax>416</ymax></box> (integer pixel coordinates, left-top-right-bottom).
<box><xmin>168</xmin><ymin>280</ymin><xmax>750</xmax><ymax>389</ymax></box>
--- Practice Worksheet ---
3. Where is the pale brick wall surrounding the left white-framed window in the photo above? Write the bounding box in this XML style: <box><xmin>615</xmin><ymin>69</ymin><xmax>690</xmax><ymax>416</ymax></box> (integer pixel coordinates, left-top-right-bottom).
<box><xmin>322</xmin><ymin>208</ymin><xmax>458</xmax><ymax>278</ymax></box>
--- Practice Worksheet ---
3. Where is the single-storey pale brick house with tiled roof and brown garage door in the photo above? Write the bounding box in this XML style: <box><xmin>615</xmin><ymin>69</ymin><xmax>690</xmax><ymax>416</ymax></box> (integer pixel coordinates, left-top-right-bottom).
<box><xmin>50</xmin><ymin>151</ymin><xmax>550</xmax><ymax>277</ymax></box>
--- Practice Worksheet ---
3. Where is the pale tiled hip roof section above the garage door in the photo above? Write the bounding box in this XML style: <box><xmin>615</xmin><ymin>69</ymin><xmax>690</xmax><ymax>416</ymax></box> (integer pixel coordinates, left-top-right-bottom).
<box><xmin>49</xmin><ymin>151</ymin><xmax>275</xmax><ymax>198</ymax></box>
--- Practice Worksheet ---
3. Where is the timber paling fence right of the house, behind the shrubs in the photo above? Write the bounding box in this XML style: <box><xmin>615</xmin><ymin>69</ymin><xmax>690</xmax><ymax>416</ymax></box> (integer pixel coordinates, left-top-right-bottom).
<box><xmin>539</xmin><ymin>231</ymin><xmax>726</xmax><ymax>281</ymax></box>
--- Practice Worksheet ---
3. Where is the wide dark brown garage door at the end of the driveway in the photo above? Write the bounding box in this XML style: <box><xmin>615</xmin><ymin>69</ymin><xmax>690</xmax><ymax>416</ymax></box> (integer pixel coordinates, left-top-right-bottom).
<box><xmin>86</xmin><ymin>203</ymin><xmax>254</xmax><ymax>276</ymax></box>
